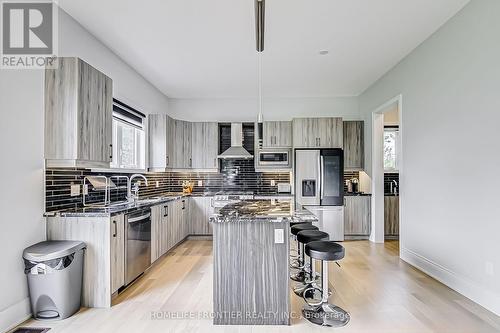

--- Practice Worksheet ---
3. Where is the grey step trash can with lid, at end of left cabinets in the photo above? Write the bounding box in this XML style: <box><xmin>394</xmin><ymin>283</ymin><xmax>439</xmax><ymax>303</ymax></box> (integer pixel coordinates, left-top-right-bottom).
<box><xmin>23</xmin><ymin>241</ymin><xmax>85</xmax><ymax>320</ymax></box>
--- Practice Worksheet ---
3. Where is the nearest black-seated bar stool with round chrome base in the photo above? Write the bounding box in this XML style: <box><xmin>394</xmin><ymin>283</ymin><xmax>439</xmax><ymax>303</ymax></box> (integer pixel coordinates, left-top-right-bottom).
<box><xmin>302</xmin><ymin>241</ymin><xmax>350</xmax><ymax>327</ymax></box>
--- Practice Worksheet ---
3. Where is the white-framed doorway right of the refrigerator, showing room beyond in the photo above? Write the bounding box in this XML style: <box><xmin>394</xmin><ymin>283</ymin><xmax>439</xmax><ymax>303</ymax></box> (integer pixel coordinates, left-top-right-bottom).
<box><xmin>370</xmin><ymin>95</ymin><xmax>404</xmax><ymax>252</ymax></box>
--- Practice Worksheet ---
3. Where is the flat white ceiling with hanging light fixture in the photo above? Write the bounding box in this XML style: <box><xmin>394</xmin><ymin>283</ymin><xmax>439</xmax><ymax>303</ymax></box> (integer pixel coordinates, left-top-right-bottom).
<box><xmin>59</xmin><ymin>0</ymin><xmax>469</xmax><ymax>98</ymax></box>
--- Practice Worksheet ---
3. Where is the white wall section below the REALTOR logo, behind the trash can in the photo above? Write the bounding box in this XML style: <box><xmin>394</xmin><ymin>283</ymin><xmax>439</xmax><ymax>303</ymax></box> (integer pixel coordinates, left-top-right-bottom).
<box><xmin>0</xmin><ymin>70</ymin><xmax>45</xmax><ymax>332</ymax></box>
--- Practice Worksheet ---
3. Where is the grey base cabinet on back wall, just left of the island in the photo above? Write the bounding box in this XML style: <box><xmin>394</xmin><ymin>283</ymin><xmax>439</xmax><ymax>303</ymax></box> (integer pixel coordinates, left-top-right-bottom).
<box><xmin>189</xmin><ymin>197</ymin><xmax>215</xmax><ymax>235</ymax></box>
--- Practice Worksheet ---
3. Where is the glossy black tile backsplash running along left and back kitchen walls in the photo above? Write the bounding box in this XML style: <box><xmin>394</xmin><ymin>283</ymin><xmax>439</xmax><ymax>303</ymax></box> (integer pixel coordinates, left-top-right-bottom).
<box><xmin>45</xmin><ymin>164</ymin><xmax>290</xmax><ymax>212</ymax></box>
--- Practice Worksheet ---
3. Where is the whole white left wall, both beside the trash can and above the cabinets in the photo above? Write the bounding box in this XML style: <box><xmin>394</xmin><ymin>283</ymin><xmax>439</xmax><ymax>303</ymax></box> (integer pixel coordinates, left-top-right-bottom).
<box><xmin>0</xmin><ymin>7</ymin><xmax>168</xmax><ymax>332</ymax></box>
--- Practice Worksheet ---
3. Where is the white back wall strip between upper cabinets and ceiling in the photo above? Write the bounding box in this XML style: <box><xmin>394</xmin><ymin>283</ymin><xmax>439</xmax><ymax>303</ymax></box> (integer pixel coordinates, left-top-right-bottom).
<box><xmin>169</xmin><ymin>97</ymin><xmax>360</xmax><ymax>121</ymax></box>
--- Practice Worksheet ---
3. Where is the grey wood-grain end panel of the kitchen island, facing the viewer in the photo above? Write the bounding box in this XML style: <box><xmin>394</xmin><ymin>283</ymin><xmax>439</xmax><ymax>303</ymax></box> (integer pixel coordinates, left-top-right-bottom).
<box><xmin>213</xmin><ymin>221</ymin><xmax>290</xmax><ymax>325</ymax></box>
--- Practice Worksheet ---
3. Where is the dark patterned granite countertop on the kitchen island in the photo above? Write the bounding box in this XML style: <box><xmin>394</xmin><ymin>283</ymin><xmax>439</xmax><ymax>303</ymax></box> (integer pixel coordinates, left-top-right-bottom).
<box><xmin>210</xmin><ymin>200</ymin><xmax>317</xmax><ymax>223</ymax></box>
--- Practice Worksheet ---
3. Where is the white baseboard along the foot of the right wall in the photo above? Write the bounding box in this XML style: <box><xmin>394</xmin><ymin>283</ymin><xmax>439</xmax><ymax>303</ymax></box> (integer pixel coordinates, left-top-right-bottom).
<box><xmin>401</xmin><ymin>248</ymin><xmax>500</xmax><ymax>316</ymax></box>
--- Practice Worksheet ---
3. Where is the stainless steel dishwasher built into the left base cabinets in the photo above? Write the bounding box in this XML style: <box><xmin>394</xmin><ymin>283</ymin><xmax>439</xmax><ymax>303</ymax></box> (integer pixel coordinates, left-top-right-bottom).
<box><xmin>125</xmin><ymin>208</ymin><xmax>151</xmax><ymax>285</ymax></box>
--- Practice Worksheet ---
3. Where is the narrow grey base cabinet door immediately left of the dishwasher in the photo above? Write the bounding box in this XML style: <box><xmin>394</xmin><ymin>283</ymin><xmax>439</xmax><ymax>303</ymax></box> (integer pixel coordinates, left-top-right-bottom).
<box><xmin>111</xmin><ymin>214</ymin><xmax>125</xmax><ymax>293</ymax></box>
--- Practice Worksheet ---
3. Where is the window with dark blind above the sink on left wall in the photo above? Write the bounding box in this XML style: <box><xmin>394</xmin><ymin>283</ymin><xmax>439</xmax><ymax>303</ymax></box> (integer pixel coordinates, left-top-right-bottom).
<box><xmin>111</xmin><ymin>100</ymin><xmax>146</xmax><ymax>169</ymax></box>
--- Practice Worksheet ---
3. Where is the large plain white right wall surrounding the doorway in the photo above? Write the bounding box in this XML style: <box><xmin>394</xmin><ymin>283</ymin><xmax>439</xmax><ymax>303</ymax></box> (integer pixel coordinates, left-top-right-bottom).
<box><xmin>360</xmin><ymin>0</ymin><xmax>500</xmax><ymax>314</ymax></box>
